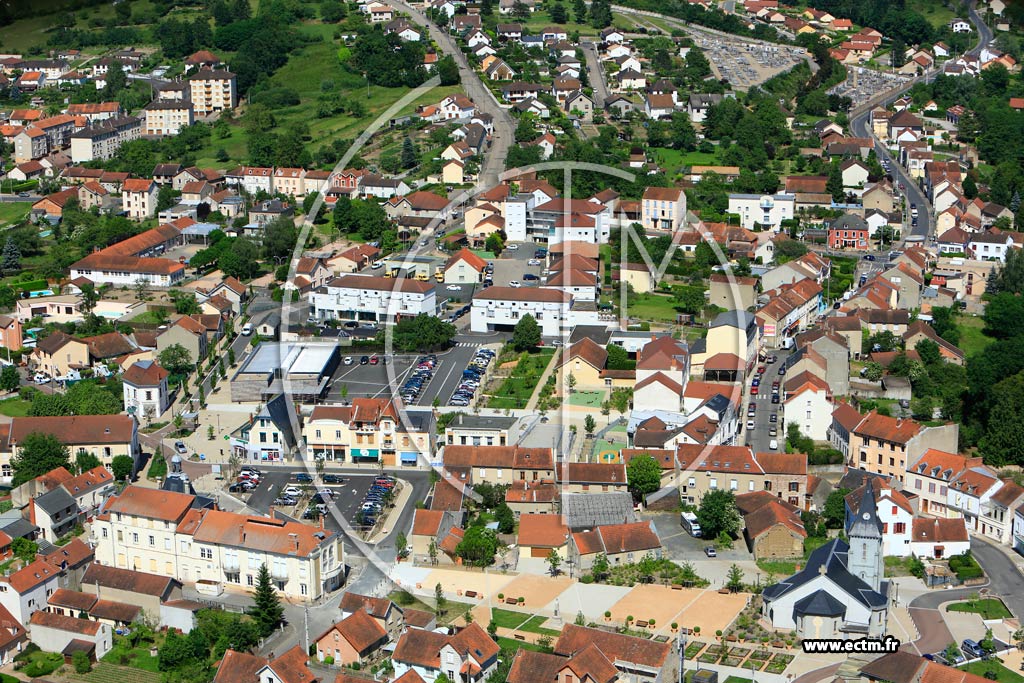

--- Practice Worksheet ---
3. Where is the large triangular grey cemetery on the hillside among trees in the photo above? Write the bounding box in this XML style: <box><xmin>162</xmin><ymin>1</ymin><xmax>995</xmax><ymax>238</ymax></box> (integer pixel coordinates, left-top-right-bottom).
<box><xmin>691</xmin><ymin>31</ymin><xmax>806</xmax><ymax>90</ymax></box>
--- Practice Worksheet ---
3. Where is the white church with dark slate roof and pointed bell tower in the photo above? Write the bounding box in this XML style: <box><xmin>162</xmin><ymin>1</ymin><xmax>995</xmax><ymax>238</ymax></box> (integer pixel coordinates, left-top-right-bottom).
<box><xmin>762</xmin><ymin>486</ymin><xmax>889</xmax><ymax>639</ymax></box>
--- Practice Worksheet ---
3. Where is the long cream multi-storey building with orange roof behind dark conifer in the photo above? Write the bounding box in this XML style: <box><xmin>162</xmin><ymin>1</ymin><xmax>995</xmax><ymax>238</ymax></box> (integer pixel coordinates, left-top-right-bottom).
<box><xmin>92</xmin><ymin>486</ymin><xmax>344</xmax><ymax>601</ymax></box>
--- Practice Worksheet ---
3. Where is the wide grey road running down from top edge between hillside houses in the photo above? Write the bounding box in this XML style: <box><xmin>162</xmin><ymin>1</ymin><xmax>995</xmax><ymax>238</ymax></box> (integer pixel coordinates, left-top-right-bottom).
<box><xmin>392</xmin><ymin>0</ymin><xmax>515</xmax><ymax>188</ymax></box>
